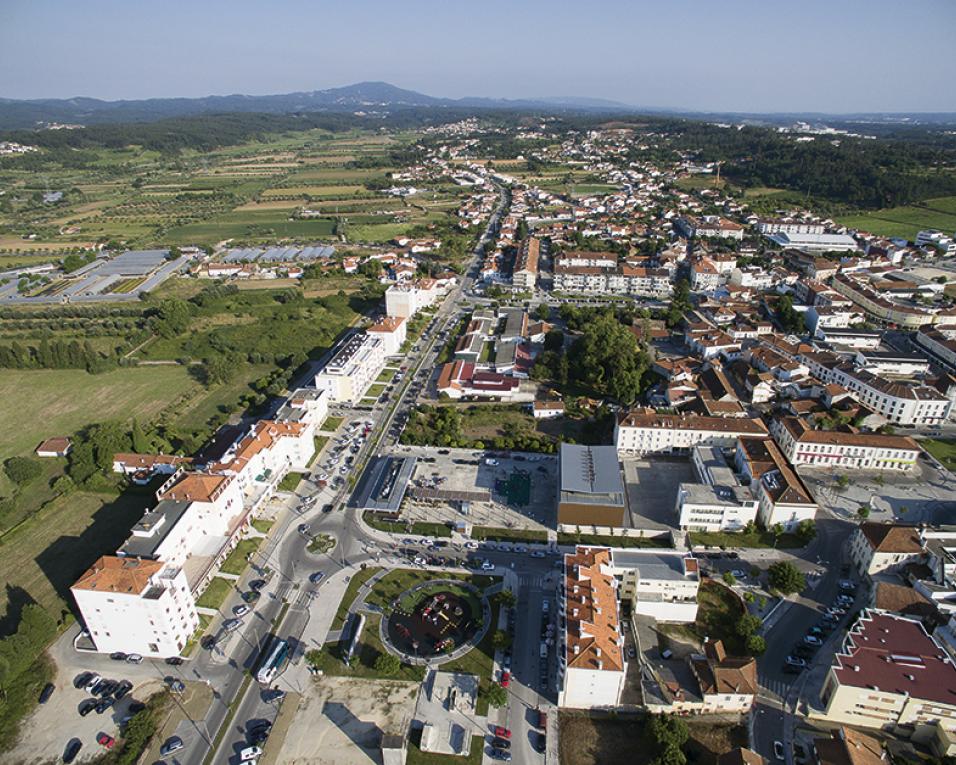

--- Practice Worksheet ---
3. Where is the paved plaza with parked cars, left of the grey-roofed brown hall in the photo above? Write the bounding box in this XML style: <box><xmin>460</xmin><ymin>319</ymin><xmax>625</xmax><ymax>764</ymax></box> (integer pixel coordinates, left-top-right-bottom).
<box><xmin>396</xmin><ymin>447</ymin><xmax>557</xmax><ymax>530</ymax></box>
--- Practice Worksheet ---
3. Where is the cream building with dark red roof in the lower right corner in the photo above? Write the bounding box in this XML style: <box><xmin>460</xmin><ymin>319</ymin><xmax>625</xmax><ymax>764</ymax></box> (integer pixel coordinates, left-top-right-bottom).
<box><xmin>821</xmin><ymin>609</ymin><xmax>956</xmax><ymax>737</ymax></box>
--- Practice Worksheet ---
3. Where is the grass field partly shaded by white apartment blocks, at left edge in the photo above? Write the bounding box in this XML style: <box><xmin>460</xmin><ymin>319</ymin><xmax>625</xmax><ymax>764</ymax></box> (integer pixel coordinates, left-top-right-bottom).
<box><xmin>0</xmin><ymin>492</ymin><xmax>148</xmax><ymax>634</ymax></box>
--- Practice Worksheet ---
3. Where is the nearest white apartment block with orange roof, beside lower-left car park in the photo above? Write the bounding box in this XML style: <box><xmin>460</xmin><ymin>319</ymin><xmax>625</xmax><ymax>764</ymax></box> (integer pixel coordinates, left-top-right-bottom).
<box><xmin>70</xmin><ymin>556</ymin><xmax>199</xmax><ymax>658</ymax></box>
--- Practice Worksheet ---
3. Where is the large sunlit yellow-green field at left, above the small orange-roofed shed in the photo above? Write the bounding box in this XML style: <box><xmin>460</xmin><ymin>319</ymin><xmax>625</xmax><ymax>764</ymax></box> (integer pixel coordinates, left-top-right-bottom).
<box><xmin>0</xmin><ymin>366</ymin><xmax>199</xmax><ymax>459</ymax></box>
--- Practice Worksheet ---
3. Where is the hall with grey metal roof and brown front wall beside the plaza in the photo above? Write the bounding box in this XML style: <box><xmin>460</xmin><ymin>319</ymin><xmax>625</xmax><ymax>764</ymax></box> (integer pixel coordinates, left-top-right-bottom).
<box><xmin>558</xmin><ymin>443</ymin><xmax>627</xmax><ymax>527</ymax></box>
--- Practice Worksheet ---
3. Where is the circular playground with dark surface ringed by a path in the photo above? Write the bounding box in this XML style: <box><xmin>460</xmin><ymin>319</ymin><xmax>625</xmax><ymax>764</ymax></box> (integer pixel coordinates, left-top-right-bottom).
<box><xmin>381</xmin><ymin>579</ymin><xmax>491</xmax><ymax>664</ymax></box>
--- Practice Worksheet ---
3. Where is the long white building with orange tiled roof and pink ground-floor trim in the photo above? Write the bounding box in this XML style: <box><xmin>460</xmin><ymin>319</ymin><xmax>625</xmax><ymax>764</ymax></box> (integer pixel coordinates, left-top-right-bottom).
<box><xmin>774</xmin><ymin>417</ymin><xmax>920</xmax><ymax>471</ymax></box>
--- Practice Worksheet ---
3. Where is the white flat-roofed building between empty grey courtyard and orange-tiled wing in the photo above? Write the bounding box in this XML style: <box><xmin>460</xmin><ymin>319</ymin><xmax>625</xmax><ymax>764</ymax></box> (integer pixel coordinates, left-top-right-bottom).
<box><xmin>675</xmin><ymin>446</ymin><xmax>757</xmax><ymax>531</ymax></box>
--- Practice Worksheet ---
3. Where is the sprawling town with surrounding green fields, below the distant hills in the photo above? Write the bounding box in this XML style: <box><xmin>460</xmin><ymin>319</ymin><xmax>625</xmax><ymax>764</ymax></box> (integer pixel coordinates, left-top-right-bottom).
<box><xmin>0</xmin><ymin>26</ymin><xmax>956</xmax><ymax>765</ymax></box>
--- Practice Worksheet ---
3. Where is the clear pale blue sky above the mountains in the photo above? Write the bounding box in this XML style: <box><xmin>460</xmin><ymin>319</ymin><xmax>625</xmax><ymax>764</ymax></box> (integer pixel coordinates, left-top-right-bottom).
<box><xmin>0</xmin><ymin>0</ymin><xmax>956</xmax><ymax>113</ymax></box>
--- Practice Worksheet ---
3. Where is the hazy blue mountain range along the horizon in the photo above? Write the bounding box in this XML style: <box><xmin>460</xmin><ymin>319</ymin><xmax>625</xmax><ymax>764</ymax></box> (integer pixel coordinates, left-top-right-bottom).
<box><xmin>0</xmin><ymin>82</ymin><xmax>956</xmax><ymax>130</ymax></box>
